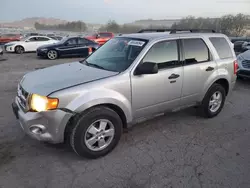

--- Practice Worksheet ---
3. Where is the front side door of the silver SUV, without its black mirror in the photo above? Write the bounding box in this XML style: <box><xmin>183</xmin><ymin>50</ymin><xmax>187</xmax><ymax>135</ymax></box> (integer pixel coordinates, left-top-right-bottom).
<box><xmin>131</xmin><ymin>39</ymin><xmax>183</xmax><ymax>118</ymax></box>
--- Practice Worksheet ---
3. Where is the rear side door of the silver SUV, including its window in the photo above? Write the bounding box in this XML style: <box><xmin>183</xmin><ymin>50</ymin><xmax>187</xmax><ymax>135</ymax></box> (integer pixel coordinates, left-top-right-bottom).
<box><xmin>181</xmin><ymin>38</ymin><xmax>216</xmax><ymax>106</ymax></box>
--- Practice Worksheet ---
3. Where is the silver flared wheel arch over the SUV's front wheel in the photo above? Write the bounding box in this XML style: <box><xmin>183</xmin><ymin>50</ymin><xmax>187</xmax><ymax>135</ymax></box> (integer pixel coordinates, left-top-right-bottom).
<box><xmin>66</xmin><ymin>88</ymin><xmax>133</xmax><ymax>123</ymax></box>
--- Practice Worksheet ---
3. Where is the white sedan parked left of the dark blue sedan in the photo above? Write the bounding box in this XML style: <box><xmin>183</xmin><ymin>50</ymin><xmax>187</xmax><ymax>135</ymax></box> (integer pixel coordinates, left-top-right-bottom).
<box><xmin>4</xmin><ymin>36</ymin><xmax>58</xmax><ymax>54</ymax></box>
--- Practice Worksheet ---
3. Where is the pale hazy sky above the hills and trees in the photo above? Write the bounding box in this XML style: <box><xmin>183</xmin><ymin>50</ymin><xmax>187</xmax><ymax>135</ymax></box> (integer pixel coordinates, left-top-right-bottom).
<box><xmin>0</xmin><ymin>0</ymin><xmax>250</xmax><ymax>24</ymax></box>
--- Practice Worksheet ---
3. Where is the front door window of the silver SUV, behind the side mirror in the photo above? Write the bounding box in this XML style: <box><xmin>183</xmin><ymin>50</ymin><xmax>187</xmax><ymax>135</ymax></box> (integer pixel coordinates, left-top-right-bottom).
<box><xmin>143</xmin><ymin>40</ymin><xmax>179</xmax><ymax>69</ymax></box>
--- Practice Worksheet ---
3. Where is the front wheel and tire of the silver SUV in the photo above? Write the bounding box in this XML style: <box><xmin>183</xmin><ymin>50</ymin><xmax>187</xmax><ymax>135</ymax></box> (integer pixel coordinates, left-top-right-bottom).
<box><xmin>69</xmin><ymin>107</ymin><xmax>123</xmax><ymax>159</ymax></box>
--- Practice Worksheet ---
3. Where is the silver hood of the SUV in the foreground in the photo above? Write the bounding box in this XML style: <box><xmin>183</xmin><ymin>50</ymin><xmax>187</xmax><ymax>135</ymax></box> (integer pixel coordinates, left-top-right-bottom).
<box><xmin>20</xmin><ymin>62</ymin><xmax>117</xmax><ymax>96</ymax></box>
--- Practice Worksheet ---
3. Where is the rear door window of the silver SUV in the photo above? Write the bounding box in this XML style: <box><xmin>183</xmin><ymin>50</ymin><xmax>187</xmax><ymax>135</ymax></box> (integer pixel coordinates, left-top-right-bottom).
<box><xmin>183</xmin><ymin>39</ymin><xmax>210</xmax><ymax>65</ymax></box>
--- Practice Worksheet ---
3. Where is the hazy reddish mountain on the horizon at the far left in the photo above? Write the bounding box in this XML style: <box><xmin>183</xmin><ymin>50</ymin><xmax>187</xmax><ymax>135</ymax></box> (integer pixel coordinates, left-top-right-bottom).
<box><xmin>0</xmin><ymin>17</ymin><xmax>68</xmax><ymax>28</ymax></box>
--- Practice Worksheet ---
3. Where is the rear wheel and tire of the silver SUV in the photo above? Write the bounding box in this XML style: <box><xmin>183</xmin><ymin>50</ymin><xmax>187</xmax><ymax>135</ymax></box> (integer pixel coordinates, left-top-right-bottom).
<box><xmin>200</xmin><ymin>84</ymin><xmax>226</xmax><ymax>118</ymax></box>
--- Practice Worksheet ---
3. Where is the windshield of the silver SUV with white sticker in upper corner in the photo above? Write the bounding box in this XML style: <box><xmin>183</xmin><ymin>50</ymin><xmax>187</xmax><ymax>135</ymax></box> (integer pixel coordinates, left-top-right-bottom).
<box><xmin>82</xmin><ymin>37</ymin><xmax>148</xmax><ymax>72</ymax></box>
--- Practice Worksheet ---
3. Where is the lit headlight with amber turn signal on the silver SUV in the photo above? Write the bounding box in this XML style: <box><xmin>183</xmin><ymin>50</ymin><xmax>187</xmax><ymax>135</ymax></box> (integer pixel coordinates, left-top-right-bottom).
<box><xmin>30</xmin><ymin>94</ymin><xmax>59</xmax><ymax>112</ymax></box>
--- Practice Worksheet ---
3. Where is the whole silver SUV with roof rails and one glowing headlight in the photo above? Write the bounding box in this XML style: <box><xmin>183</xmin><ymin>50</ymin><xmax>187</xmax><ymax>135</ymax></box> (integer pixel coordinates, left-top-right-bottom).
<box><xmin>12</xmin><ymin>31</ymin><xmax>237</xmax><ymax>158</ymax></box>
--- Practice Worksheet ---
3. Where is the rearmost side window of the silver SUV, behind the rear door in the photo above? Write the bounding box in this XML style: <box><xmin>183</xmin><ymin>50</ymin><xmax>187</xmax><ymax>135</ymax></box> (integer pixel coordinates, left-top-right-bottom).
<box><xmin>209</xmin><ymin>37</ymin><xmax>233</xmax><ymax>59</ymax></box>
